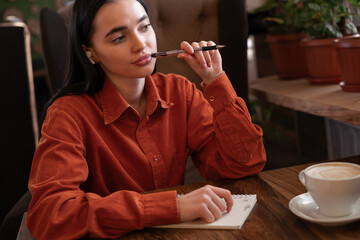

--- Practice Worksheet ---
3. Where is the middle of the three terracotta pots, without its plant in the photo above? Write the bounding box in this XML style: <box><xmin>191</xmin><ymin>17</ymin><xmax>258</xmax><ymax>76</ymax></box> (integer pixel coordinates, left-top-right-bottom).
<box><xmin>301</xmin><ymin>38</ymin><xmax>342</xmax><ymax>84</ymax></box>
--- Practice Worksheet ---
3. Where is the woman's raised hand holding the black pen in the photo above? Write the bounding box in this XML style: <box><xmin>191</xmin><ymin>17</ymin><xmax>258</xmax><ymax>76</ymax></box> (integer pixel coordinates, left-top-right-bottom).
<box><xmin>178</xmin><ymin>41</ymin><xmax>223</xmax><ymax>85</ymax></box>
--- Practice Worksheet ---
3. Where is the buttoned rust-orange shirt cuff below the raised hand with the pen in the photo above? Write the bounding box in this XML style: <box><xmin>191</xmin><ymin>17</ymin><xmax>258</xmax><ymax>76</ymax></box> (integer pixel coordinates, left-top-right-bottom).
<box><xmin>201</xmin><ymin>72</ymin><xmax>237</xmax><ymax>112</ymax></box>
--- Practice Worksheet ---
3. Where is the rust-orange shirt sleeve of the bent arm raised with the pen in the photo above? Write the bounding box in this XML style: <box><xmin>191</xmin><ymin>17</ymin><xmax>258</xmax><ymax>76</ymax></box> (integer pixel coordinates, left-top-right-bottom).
<box><xmin>187</xmin><ymin>72</ymin><xmax>266</xmax><ymax>180</ymax></box>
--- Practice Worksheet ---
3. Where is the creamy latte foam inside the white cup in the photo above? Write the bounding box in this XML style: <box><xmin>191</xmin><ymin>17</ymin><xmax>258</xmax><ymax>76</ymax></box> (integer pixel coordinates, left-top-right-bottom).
<box><xmin>307</xmin><ymin>164</ymin><xmax>360</xmax><ymax>179</ymax></box>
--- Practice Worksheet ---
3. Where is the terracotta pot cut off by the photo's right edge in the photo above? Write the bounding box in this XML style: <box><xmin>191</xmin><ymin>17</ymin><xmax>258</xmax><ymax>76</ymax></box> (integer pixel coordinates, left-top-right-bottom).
<box><xmin>335</xmin><ymin>36</ymin><xmax>360</xmax><ymax>92</ymax></box>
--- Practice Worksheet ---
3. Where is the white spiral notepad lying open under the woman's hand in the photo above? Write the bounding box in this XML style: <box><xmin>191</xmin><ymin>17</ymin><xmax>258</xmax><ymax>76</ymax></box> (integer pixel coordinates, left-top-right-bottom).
<box><xmin>156</xmin><ymin>194</ymin><xmax>256</xmax><ymax>230</ymax></box>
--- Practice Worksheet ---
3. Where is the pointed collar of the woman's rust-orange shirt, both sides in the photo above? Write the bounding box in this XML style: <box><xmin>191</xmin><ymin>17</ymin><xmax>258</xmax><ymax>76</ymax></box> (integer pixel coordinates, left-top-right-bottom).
<box><xmin>99</xmin><ymin>76</ymin><xmax>174</xmax><ymax>125</ymax></box>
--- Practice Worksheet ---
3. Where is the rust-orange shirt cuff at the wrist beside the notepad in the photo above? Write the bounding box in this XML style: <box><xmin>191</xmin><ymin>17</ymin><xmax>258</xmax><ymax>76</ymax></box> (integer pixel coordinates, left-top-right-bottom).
<box><xmin>142</xmin><ymin>191</ymin><xmax>180</xmax><ymax>227</ymax></box>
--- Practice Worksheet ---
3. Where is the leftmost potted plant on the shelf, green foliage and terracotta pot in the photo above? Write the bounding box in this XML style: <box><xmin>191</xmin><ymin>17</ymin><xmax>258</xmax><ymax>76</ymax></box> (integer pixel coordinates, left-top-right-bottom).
<box><xmin>254</xmin><ymin>0</ymin><xmax>307</xmax><ymax>79</ymax></box>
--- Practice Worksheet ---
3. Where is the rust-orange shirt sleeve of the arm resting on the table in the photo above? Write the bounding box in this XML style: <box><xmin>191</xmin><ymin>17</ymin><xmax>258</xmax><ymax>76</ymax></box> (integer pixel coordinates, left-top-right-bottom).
<box><xmin>27</xmin><ymin>106</ymin><xmax>179</xmax><ymax>240</ymax></box>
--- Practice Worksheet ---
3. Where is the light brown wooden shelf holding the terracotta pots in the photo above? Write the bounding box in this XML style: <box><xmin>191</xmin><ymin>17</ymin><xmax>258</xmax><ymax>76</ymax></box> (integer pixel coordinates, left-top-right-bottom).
<box><xmin>249</xmin><ymin>75</ymin><xmax>360</xmax><ymax>125</ymax></box>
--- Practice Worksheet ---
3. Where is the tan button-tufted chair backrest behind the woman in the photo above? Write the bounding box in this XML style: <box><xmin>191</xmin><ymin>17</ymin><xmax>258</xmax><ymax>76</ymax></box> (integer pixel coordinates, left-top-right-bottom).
<box><xmin>145</xmin><ymin>0</ymin><xmax>219</xmax><ymax>87</ymax></box>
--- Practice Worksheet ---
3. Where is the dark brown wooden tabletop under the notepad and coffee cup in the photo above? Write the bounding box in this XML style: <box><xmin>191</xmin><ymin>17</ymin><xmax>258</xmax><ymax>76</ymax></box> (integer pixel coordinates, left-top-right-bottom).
<box><xmin>116</xmin><ymin>156</ymin><xmax>360</xmax><ymax>240</ymax></box>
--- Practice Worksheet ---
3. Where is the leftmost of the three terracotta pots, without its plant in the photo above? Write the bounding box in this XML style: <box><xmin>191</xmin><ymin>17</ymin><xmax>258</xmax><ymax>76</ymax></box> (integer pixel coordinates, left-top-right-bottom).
<box><xmin>265</xmin><ymin>34</ymin><xmax>307</xmax><ymax>79</ymax></box>
